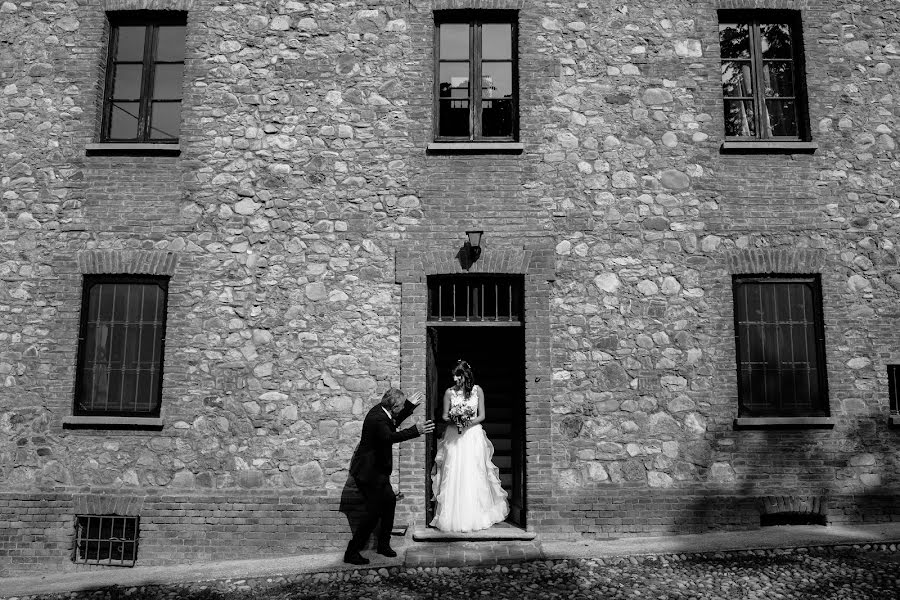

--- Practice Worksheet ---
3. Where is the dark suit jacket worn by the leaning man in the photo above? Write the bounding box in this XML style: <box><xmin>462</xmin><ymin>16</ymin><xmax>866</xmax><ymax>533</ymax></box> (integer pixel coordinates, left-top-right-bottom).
<box><xmin>350</xmin><ymin>400</ymin><xmax>419</xmax><ymax>483</ymax></box>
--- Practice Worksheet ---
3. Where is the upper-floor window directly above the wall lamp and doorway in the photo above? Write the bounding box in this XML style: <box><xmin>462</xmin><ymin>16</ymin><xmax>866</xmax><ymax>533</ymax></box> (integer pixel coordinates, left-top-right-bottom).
<box><xmin>434</xmin><ymin>11</ymin><xmax>518</xmax><ymax>142</ymax></box>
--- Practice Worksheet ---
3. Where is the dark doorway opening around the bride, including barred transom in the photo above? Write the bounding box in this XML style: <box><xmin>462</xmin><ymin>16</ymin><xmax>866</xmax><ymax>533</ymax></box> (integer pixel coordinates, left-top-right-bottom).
<box><xmin>425</xmin><ymin>275</ymin><xmax>525</xmax><ymax>528</ymax></box>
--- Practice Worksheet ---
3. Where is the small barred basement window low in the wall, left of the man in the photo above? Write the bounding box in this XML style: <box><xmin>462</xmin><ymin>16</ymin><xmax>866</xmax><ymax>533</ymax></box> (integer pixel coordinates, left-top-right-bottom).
<box><xmin>72</xmin><ymin>515</ymin><xmax>140</xmax><ymax>567</ymax></box>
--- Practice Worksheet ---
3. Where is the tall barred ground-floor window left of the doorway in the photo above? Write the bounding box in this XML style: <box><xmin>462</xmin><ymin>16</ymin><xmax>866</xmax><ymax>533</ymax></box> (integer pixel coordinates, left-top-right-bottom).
<box><xmin>74</xmin><ymin>275</ymin><xmax>168</xmax><ymax>417</ymax></box>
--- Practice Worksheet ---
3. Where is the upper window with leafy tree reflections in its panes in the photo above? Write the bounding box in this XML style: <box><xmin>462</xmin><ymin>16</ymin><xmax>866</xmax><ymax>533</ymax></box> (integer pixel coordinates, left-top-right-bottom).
<box><xmin>719</xmin><ymin>10</ymin><xmax>809</xmax><ymax>141</ymax></box>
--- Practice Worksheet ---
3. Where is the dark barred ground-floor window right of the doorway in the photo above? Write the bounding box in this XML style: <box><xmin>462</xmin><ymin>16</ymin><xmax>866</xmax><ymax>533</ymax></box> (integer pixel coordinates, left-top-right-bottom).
<box><xmin>734</xmin><ymin>276</ymin><xmax>828</xmax><ymax>417</ymax></box>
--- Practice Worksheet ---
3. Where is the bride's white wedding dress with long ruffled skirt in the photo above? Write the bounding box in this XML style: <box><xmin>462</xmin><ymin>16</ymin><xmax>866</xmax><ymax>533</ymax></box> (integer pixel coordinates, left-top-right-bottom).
<box><xmin>431</xmin><ymin>389</ymin><xmax>509</xmax><ymax>532</ymax></box>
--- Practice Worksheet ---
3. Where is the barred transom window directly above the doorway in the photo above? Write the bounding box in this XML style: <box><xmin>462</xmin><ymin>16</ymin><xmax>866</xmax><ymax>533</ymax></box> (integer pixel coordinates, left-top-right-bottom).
<box><xmin>428</xmin><ymin>275</ymin><xmax>523</xmax><ymax>323</ymax></box>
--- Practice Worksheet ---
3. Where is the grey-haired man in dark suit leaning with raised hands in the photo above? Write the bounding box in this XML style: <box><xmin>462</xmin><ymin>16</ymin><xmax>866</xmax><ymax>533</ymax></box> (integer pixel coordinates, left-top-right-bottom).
<box><xmin>344</xmin><ymin>388</ymin><xmax>434</xmax><ymax>565</ymax></box>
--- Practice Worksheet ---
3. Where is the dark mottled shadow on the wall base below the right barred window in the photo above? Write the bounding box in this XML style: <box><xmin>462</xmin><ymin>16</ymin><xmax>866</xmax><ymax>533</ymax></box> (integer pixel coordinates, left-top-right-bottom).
<box><xmin>676</xmin><ymin>419</ymin><xmax>900</xmax><ymax>544</ymax></box>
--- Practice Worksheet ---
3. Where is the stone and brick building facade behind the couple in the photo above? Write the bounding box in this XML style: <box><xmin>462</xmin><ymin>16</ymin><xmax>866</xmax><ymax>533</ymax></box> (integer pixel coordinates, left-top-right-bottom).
<box><xmin>0</xmin><ymin>0</ymin><xmax>900</xmax><ymax>575</ymax></box>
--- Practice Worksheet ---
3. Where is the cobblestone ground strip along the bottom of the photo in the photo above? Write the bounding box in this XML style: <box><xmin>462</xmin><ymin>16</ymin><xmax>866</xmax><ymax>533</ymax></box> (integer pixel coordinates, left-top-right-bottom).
<box><xmin>20</xmin><ymin>550</ymin><xmax>900</xmax><ymax>600</ymax></box>
